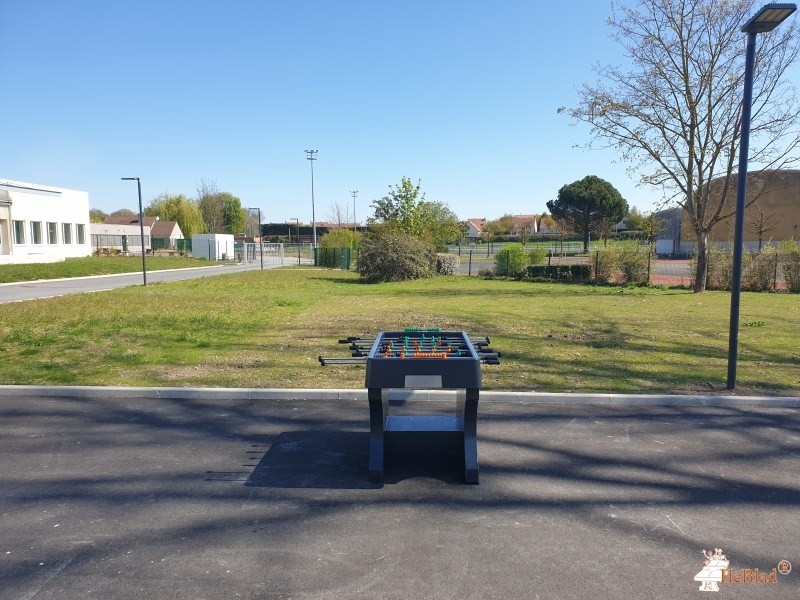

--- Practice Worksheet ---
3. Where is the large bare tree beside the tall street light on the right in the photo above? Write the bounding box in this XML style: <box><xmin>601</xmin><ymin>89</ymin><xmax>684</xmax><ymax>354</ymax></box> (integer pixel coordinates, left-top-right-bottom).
<box><xmin>559</xmin><ymin>0</ymin><xmax>800</xmax><ymax>292</ymax></box>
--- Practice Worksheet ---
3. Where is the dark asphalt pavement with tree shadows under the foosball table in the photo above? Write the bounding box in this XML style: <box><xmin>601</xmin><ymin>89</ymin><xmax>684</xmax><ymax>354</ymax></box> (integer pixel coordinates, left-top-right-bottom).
<box><xmin>0</xmin><ymin>386</ymin><xmax>800</xmax><ymax>600</ymax></box>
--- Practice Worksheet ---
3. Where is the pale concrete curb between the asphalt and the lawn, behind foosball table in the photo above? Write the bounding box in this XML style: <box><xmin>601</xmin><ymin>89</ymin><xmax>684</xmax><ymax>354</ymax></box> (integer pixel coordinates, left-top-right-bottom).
<box><xmin>0</xmin><ymin>385</ymin><xmax>800</xmax><ymax>408</ymax></box>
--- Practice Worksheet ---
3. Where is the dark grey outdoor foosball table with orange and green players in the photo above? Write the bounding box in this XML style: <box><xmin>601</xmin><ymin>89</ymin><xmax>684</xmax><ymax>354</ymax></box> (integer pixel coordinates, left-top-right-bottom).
<box><xmin>319</xmin><ymin>328</ymin><xmax>500</xmax><ymax>483</ymax></box>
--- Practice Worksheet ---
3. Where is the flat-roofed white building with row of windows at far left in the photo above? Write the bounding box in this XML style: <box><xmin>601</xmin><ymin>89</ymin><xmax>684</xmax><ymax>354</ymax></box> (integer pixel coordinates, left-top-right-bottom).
<box><xmin>0</xmin><ymin>179</ymin><xmax>92</xmax><ymax>264</ymax></box>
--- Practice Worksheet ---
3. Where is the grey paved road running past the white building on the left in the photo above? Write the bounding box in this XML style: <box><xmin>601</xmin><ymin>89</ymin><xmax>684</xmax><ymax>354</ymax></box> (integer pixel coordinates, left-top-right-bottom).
<box><xmin>0</xmin><ymin>262</ymin><xmax>304</xmax><ymax>304</ymax></box>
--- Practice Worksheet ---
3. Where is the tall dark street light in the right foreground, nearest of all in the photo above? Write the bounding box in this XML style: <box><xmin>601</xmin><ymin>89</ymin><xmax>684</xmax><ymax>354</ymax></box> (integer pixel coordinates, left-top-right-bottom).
<box><xmin>727</xmin><ymin>3</ymin><xmax>797</xmax><ymax>390</ymax></box>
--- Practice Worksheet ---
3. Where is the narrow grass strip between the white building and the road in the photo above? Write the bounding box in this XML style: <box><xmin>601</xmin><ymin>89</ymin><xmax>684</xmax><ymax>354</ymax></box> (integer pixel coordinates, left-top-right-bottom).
<box><xmin>0</xmin><ymin>256</ymin><xmax>215</xmax><ymax>283</ymax></box>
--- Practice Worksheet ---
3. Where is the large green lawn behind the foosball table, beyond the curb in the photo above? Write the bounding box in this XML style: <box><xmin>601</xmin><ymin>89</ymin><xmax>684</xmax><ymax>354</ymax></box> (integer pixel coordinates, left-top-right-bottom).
<box><xmin>0</xmin><ymin>268</ymin><xmax>800</xmax><ymax>396</ymax></box>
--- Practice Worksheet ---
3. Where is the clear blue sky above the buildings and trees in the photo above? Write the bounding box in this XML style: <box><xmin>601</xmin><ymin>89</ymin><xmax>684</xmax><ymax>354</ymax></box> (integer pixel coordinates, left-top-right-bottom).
<box><xmin>0</xmin><ymin>0</ymin><xmax>708</xmax><ymax>223</ymax></box>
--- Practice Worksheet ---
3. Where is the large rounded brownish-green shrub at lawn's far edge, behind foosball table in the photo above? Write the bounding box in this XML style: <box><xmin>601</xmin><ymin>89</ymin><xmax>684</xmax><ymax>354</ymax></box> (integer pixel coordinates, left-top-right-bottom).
<box><xmin>356</xmin><ymin>228</ymin><xmax>436</xmax><ymax>283</ymax></box>
